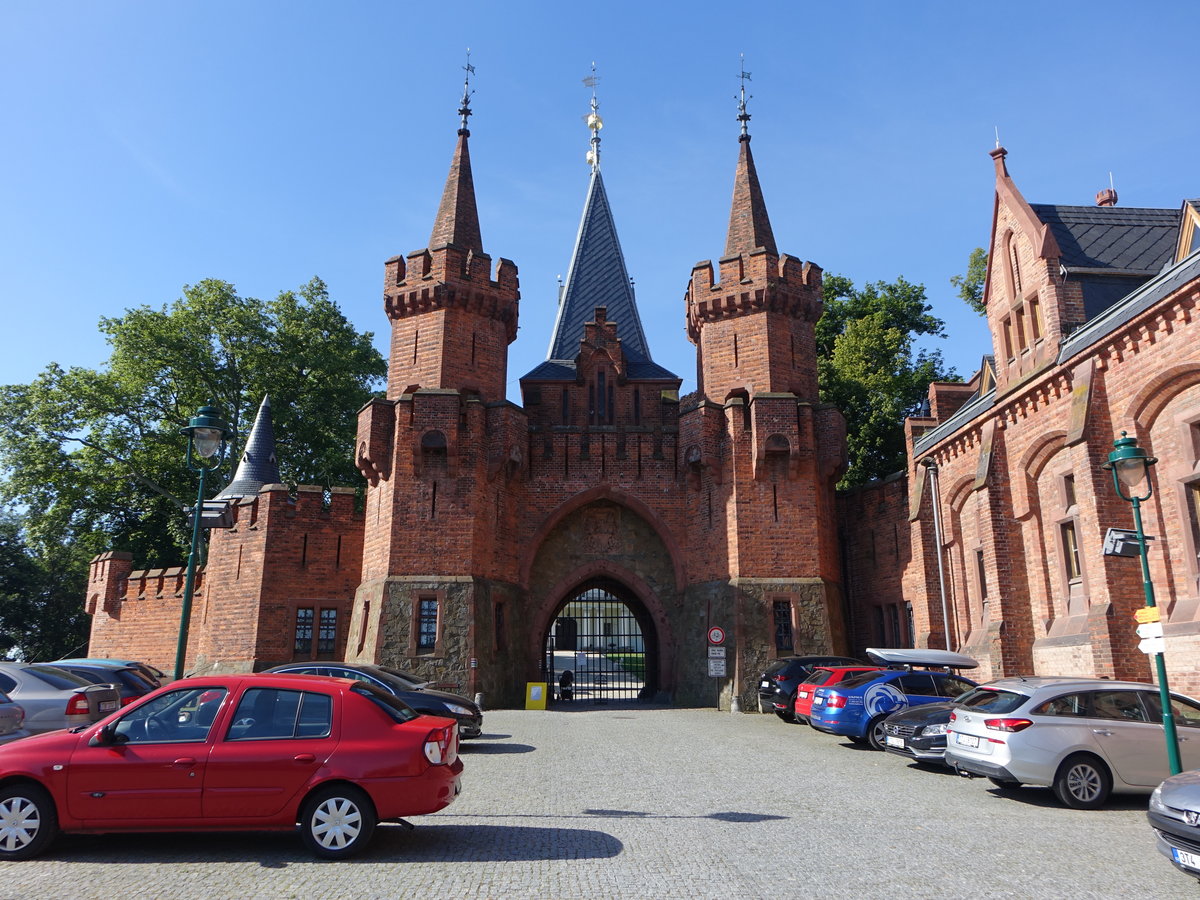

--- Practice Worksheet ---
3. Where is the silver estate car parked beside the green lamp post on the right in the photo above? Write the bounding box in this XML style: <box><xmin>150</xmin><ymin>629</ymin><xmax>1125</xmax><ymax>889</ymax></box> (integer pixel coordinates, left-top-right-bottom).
<box><xmin>946</xmin><ymin>677</ymin><xmax>1200</xmax><ymax>809</ymax></box>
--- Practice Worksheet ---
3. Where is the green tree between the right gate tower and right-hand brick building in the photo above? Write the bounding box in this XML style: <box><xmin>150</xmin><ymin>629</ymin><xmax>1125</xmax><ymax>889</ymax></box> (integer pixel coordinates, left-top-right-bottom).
<box><xmin>816</xmin><ymin>275</ymin><xmax>958</xmax><ymax>487</ymax></box>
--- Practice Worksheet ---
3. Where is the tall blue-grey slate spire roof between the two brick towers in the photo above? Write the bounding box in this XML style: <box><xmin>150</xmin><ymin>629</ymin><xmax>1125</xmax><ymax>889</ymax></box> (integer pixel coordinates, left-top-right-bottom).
<box><xmin>546</xmin><ymin>168</ymin><xmax>650</xmax><ymax>362</ymax></box>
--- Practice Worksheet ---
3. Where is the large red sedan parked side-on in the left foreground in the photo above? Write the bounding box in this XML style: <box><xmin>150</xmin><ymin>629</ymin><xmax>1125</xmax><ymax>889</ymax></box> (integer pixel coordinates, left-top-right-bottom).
<box><xmin>0</xmin><ymin>674</ymin><xmax>462</xmax><ymax>860</ymax></box>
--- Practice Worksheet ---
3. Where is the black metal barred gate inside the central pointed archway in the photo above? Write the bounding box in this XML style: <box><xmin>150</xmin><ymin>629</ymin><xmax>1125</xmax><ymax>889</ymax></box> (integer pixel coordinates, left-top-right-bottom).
<box><xmin>544</xmin><ymin>587</ymin><xmax>653</xmax><ymax>704</ymax></box>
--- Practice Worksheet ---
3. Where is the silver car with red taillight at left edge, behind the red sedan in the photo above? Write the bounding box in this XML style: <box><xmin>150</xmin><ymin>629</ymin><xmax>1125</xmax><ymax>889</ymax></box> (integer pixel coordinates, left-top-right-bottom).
<box><xmin>0</xmin><ymin>662</ymin><xmax>121</xmax><ymax>734</ymax></box>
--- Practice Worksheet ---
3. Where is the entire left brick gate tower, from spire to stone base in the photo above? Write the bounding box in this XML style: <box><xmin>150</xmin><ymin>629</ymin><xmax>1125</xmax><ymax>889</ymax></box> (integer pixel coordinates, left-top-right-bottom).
<box><xmin>346</xmin><ymin>72</ymin><xmax>523</xmax><ymax>696</ymax></box>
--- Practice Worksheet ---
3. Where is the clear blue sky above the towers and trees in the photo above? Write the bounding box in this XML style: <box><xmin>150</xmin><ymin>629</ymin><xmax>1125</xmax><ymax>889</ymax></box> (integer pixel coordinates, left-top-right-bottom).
<box><xmin>0</xmin><ymin>0</ymin><xmax>1200</xmax><ymax>398</ymax></box>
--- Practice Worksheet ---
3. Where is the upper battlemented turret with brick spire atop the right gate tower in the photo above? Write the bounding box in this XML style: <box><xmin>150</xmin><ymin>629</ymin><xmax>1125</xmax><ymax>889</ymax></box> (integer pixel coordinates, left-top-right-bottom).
<box><xmin>685</xmin><ymin>66</ymin><xmax>822</xmax><ymax>401</ymax></box>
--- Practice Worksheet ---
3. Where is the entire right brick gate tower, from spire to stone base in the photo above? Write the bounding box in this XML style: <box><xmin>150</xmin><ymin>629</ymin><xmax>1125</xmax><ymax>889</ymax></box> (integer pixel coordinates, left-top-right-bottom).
<box><xmin>680</xmin><ymin>81</ymin><xmax>846</xmax><ymax>684</ymax></box>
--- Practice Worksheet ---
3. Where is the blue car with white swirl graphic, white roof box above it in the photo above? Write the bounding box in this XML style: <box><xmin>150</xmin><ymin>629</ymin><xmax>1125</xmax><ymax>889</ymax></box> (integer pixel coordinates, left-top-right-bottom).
<box><xmin>809</xmin><ymin>648</ymin><xmax>979</xmax><ymax>750</ymax></box>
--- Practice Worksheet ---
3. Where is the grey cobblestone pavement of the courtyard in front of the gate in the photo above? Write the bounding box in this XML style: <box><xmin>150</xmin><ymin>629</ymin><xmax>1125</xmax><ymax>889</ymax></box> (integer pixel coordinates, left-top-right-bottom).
<box><xmin>0</xmin><ymin>707</ymin><xmax>1200</xmax><ymax>900</ymax></box>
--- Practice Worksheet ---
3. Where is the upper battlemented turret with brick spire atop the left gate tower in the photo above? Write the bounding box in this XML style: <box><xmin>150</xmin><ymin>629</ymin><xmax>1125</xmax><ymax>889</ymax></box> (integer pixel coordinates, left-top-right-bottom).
<box><xmin>384</xmin><ymin>58</ymin><xmax>521</xmax><ymax>401</ymax></box>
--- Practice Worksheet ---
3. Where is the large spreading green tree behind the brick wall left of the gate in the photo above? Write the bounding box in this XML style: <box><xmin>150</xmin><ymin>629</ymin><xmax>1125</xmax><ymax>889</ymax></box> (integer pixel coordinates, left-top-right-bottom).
<box><xmin>0</xmin><ymin>278</ymin><xmax>386</xmax><ymax>571</ymax></box>
